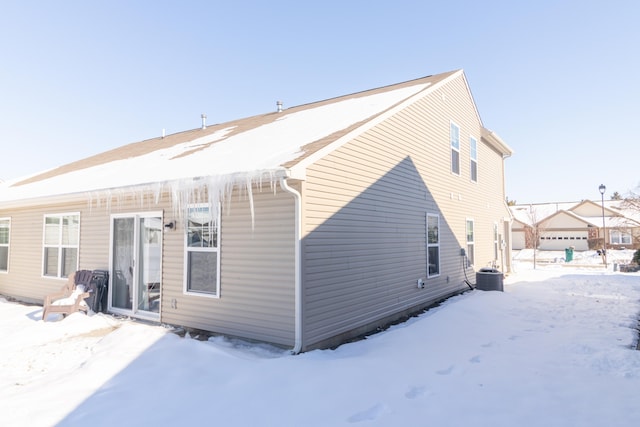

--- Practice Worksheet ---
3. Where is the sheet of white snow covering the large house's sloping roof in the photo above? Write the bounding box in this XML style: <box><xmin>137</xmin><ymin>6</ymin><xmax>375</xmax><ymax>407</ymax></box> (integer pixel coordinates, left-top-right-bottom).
<box><xmin>0</xmin><ymin>79</ymin><xmax>430</xmax><ymax>207</ymax></box>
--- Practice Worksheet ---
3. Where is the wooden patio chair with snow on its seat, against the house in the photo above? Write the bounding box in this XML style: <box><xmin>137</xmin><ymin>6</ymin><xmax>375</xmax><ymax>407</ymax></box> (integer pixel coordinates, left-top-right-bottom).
<box><xmin>42</xmin><ymin>270</ymin><xmax>92</xmax><ymax>320</ymax></box>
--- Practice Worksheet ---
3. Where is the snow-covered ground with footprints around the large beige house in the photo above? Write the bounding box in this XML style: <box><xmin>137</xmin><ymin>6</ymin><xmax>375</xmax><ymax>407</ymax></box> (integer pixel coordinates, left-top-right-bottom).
<box><xmin>0</xmin><ymin>254</ymin><xmax>640</xmax><ymax>427</ymax></box>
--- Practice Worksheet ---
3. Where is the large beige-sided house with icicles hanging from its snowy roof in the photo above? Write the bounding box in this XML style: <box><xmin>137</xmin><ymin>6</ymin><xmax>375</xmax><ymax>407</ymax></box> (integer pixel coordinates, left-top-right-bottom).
<box><xmin>0</xmin><ymin>70</ymin><xmax>512</xmax><ymax>352</ymax></box>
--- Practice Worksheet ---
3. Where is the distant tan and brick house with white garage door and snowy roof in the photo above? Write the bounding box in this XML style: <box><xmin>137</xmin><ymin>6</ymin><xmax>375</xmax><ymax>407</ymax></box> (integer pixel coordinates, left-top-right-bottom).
<box><xmin>510</xmin><ymin>200</ymin><xmax>640</xmax><ymax>251</ymax></box>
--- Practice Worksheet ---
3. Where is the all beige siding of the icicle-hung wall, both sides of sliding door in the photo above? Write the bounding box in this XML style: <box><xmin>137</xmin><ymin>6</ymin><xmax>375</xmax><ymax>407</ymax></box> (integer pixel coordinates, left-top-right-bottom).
<box><xmin>0</xmin><ymin>188</ymin><xmax>295</xmax><ymax>346</ymax></box>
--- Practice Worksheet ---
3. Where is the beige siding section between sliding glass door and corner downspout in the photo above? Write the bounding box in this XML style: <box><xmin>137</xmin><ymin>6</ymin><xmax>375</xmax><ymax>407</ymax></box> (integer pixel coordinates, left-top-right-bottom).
<box><xmin>162</xmin><ymin>188</ymin><xmax>295</xmax><ymax>346</ymax></box>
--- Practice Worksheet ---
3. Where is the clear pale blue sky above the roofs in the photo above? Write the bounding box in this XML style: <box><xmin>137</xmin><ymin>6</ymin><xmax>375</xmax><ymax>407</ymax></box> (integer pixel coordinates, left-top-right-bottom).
<box><xmin>0</xmin><ymin>0</ymin><xmax>640</xmax><ymax>203</ymax></box>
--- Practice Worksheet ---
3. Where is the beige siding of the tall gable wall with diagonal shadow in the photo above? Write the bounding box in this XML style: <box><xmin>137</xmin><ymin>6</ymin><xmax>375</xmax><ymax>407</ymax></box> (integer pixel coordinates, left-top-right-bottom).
<box><xmin>303</xmin><ymin>72</ymin><xmax>508</xmax><ymax>347</ymax></box>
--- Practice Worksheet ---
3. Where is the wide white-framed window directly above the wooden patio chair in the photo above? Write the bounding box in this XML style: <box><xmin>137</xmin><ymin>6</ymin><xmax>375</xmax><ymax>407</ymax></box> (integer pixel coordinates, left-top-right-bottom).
<box><xmin>42</xmin><ymin>213</ymin><xmax>80</xmax><ymax>278</ymax></box>
